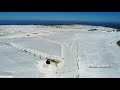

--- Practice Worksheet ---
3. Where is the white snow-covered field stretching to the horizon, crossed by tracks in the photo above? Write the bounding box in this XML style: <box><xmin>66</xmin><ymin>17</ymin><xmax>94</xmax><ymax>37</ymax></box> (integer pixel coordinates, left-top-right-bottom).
<box><xmin>0</xmin><ymin>25</ymin><xmax>120</xmax><ymax>78</ymax></box>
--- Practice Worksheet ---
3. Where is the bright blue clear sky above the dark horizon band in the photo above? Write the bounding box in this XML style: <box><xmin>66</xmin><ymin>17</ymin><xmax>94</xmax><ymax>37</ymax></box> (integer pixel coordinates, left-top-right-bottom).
<box><xmin>0</xmin><ymin>12</ymin><xmax>120</xmax><ymax>22</ymax></box>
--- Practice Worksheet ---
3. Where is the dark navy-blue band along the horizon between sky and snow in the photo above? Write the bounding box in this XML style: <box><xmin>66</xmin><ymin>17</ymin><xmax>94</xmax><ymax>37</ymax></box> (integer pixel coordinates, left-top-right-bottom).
<box><xmin>0</xmin><ymin>20</ymin><xmax>120</xmax><ymax>29</ymax></box>
